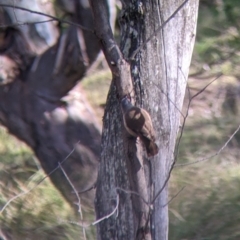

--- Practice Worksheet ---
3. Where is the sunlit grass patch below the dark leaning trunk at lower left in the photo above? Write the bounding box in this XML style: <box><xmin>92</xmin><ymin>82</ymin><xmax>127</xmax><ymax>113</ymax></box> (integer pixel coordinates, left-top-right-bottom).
<box><xmin>0</xmin><ymin>128</ymin><xmax>95</xmax><ymax>240</ymax></box>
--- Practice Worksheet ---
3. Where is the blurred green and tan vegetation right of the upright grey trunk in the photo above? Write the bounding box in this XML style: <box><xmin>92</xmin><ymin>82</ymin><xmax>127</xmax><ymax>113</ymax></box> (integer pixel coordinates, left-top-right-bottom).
<box><xmin>169</xmin><ymin>0</ymin><xmax>240</xmax><ymax>240</ymax></box>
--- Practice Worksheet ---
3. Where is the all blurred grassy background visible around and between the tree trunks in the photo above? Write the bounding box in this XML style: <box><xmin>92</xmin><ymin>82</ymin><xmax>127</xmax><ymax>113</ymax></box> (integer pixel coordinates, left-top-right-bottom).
<box><xmin>0</xmin><ymin>0</ymin><xmax>240</xmax><ymax>240</ymax></box>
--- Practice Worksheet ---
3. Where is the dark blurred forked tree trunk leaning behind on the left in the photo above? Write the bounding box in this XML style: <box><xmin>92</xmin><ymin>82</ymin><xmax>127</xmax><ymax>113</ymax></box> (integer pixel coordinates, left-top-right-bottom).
<box><xmin>0</xmin><ymin>1</ymin><xmax>101</xmax><ymax>208</ymax></box>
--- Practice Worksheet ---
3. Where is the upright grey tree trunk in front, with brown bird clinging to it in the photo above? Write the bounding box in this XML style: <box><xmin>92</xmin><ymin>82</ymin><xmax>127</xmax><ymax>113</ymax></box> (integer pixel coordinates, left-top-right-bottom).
<box><xmin>91</xmin><ymin>0</ymin><xmax>198</xmax><ymax>240</ymax></box>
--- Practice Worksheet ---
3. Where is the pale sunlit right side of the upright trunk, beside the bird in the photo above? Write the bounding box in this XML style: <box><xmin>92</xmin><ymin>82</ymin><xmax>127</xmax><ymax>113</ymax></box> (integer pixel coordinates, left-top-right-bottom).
<box><xmin>139</xmin><ymin>0</ymin><xmax>198</xmax><ymax>240</ymax></box>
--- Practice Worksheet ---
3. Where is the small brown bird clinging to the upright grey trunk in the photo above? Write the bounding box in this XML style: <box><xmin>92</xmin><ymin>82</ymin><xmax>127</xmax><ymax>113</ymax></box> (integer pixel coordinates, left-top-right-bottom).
<box><xmin>121</xmin><ymin>96</ymin><xmax>158</xmax><ymax>157</ymax></box>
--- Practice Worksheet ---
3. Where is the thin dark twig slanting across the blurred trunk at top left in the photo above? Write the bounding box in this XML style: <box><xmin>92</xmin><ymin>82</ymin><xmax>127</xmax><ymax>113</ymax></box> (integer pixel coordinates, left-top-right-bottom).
<box><xmin>0</xmin><ymin>3</ymin><xmax>94</xmax><ymax>33</ymax></box>
